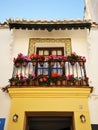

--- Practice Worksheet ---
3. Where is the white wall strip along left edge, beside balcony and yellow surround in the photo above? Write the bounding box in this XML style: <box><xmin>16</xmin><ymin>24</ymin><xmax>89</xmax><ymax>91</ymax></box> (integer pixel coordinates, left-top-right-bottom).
<box><xmin>0</xmin><ymin>29</ymin><xmax>12</xmax><ymax>129</ymax></box>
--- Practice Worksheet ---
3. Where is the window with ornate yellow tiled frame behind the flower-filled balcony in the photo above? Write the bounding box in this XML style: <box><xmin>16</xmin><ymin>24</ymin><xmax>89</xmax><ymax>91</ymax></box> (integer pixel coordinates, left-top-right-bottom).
<box><xmin>28</xmin><ymin>38</ymin><xmax>72</xmax><ymax>75</ymax></box>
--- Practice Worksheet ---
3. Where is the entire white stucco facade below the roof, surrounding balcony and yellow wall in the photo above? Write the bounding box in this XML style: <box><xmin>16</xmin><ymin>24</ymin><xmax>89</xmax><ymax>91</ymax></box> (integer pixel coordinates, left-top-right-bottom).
<box><xmin>0</xmin><ymin>21</ymin><xmax>95</xmax><ymax>130</ymax></box>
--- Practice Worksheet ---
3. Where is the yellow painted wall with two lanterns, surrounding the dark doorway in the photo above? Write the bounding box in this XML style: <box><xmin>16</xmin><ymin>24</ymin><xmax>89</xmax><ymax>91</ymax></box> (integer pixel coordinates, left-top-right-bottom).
<box><xmin>8</xmin><ymin>88</ymin><xmax>91</xmax><ymax>130</ymax></box>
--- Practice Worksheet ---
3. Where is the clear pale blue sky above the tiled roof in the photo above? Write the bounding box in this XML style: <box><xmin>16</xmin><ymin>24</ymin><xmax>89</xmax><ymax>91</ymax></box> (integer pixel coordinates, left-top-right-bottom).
<box><xmin>0</xmin><ymin>0</ymin><xmax>84</xmax><ymax>22</ymax></box>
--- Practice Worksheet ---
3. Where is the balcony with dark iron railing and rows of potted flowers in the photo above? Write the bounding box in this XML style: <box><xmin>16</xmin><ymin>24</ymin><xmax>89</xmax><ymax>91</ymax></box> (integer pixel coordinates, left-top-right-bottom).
<box><xmin>9</xmin><ymin>52</ymin><xmax>89</xmax><ymax>87</ymax></box>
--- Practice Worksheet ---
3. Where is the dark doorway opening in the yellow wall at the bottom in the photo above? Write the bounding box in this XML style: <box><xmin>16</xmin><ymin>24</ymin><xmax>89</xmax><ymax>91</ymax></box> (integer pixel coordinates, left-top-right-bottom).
<box><xmin>26</xmin><ymin>112</ymin><xmax>73</xmax><ymax>130</ymax></box>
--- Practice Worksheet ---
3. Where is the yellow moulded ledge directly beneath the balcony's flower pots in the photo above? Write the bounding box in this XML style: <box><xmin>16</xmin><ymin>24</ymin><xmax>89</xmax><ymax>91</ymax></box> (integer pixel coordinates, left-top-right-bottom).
<box><xmin>8</xmin><ymin>86</ymin><xmax>92</xmax><ymax>98</ymax></box>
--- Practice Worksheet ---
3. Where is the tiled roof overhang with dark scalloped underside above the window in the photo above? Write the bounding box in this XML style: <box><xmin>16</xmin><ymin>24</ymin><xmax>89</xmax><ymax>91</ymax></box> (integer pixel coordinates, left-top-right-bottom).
<box><xmin>8</xmin><ymin>19</ymin><xmax>91</xmax><ymax>32</ymax></box>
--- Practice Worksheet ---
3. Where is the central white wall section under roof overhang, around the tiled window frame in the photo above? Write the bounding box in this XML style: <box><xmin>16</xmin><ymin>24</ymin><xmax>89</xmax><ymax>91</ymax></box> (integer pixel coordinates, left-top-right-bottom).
<box><xmin>13</xmin><ymin>30</ymin><xmax>87</xmax><ymax>56</ymax></box>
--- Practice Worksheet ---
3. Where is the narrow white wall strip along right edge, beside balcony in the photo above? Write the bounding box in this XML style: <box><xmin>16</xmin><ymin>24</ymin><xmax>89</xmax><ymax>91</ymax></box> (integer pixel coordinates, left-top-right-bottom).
<box><xmin>88</xmin><ymin>28</ymin><xmax>98</xmax><ymax>124</ymax></box>
